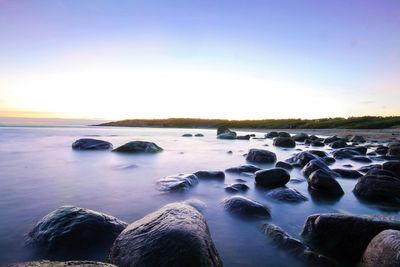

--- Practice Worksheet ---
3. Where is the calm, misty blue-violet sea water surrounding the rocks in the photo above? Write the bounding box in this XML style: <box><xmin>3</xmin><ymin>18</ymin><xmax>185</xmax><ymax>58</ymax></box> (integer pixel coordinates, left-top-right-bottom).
<box><xmin>0</xmin><ymin>127</ymin><xmax>399</xmax><ymax>266</ymax></box>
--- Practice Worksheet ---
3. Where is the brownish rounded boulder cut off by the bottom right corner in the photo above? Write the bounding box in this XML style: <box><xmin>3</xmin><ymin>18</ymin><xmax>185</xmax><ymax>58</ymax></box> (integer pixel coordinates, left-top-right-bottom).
<box><xmin>360</xmin><ymin>230</ymin><xmax>400</xmax><ymax>267</ymax></box>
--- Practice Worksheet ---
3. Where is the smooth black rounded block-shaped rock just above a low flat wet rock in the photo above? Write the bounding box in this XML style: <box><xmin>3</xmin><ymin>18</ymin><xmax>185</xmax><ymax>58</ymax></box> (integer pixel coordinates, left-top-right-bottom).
<box><xmin>255</xmin><ymin>168</ymin><xmax>290</xmax><ymax>187</ymax></box>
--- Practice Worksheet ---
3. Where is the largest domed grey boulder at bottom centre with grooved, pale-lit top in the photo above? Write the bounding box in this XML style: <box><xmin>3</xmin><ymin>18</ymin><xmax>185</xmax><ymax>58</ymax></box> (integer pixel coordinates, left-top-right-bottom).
<box><xmin>109</xmin><ymin>203</ymin><xmax>222</xmax><ymax>267</ymax></box>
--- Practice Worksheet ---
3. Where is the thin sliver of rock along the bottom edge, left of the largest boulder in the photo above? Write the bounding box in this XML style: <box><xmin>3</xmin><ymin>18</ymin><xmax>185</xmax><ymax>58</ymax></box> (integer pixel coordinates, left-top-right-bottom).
<box><xmin>6</xmin><ymin>260</ymin><xmax>116</xmax><ymax>267</ymax></box>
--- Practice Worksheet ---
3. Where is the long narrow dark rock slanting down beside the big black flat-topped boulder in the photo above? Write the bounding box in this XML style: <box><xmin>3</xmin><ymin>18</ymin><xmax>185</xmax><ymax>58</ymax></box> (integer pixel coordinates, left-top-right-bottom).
<box><xmin>261</xmin><ymin>223</ymin><xmax>337</xmax><ymax>267</ymax></box>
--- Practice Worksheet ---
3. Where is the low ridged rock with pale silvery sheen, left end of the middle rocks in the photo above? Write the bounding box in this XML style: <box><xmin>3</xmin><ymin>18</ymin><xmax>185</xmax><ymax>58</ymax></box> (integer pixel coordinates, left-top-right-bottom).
<box><xmin>157</xmin><ymin>174</ymin><xmax>199</xmax><ymax>191</ymax></box>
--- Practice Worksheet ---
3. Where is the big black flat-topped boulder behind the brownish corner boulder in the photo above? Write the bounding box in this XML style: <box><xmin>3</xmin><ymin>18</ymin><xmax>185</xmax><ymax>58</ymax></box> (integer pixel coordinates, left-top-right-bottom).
<box><xmin>301</xmin><ymin>213</ymin><xmax>400</xmax><ymax>264</ymax></box>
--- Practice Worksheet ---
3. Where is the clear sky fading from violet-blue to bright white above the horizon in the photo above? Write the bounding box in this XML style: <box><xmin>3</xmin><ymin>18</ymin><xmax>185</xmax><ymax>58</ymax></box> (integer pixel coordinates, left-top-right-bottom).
<box><xmin>0</xmin><ymin>0</ymin><xmax>400</xmax><ymax>120</ymax></box>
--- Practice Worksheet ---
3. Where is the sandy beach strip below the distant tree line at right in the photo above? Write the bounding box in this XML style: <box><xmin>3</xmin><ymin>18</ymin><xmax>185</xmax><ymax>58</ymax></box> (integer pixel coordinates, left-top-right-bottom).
<box><xmin>232</xmin><ymin>128</ymin><xmax>400</xmax><ymax>142</ymax></box>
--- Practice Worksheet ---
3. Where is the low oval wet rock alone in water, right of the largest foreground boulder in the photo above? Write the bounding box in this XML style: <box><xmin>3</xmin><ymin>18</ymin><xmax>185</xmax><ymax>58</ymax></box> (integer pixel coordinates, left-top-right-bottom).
<box><xmin>222</xmin><ymin>196</ymin><xmax>271</xmax><ymax>218</ymax></box>
